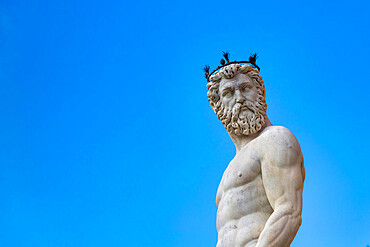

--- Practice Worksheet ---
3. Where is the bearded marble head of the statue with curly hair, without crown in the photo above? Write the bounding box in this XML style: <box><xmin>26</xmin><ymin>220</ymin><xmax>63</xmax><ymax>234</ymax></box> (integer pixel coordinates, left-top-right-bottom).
<box><xmin>207</xmin><ymin>64</ymin><xmax>267</xmax><ymax>136</ymax></box>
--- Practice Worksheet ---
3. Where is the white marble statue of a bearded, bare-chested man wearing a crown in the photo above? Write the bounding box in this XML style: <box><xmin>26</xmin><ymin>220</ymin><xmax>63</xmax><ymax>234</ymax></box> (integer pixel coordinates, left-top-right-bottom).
<box><xmin>205</xmin><ymin>56</ymin><xmax>305</xmax><ymax>247</ymax></box>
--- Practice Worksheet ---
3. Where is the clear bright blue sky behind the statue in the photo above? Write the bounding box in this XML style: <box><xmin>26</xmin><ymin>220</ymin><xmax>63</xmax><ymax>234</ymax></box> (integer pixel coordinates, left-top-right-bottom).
<box><xmin>0</xmin><ymin>0</ymin><xmax>370</xmax><ymax>247</ymax></box>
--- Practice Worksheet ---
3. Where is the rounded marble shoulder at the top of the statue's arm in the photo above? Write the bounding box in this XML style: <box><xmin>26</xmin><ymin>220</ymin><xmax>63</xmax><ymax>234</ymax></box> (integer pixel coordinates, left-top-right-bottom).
<box><xmin>260</xmin><ymin>126</ymin><xmax>303</xmax><ymax>166</ymax></box>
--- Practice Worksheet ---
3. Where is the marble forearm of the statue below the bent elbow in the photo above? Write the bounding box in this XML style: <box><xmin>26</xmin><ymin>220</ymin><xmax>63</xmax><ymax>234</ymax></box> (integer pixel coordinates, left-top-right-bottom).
<box><xmin>255</xmin><ymin>205</ymin><xmax>302</xmax><ymax>247</ymax></box>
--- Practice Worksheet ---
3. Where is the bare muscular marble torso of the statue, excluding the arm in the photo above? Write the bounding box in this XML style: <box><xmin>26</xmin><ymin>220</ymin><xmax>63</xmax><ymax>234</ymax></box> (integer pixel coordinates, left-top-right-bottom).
<box><xmin>216</xmin><ymin>137</ymin><xmax>273</xmax><ymax>247</ymax></box>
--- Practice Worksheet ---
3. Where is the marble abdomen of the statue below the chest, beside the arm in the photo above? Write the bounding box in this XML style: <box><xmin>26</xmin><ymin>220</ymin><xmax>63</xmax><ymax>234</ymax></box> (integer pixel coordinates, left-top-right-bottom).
<box><xmin>217</xmin><ymin>176</ymin><xmax>273</xmax><ymax>247</ymax></box>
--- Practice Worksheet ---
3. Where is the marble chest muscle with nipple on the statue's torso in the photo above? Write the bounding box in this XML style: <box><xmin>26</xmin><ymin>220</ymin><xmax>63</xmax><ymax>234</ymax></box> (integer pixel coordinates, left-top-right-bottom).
<box><xmin>220</xmin><ymin>150</ymin><xmax>261</xmax><ymax>192</ymax></box>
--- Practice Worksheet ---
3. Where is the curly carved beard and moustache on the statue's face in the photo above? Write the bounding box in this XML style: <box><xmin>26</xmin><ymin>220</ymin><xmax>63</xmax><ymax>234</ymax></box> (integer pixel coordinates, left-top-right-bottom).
<box><xmin>217</xmin><ymin>101</ymin><xmax>266</xmax><ymax>136</ymax></box>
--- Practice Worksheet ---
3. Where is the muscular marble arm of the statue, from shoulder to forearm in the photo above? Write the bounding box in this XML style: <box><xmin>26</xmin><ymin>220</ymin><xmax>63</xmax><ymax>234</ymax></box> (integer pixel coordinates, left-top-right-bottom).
<box><xmin>256</xmin><ymin>129</ymin><xmax>304</xmax><ymax>247</ymax></box>
